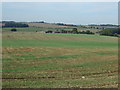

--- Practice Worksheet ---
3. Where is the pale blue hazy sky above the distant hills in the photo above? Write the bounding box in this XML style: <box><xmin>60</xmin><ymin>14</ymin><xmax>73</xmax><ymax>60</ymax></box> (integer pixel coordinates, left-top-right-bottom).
<box><xmin>2</xmin><ymin>2</ymin><xmax>118</xmax><ymax>25</ymax></box>
